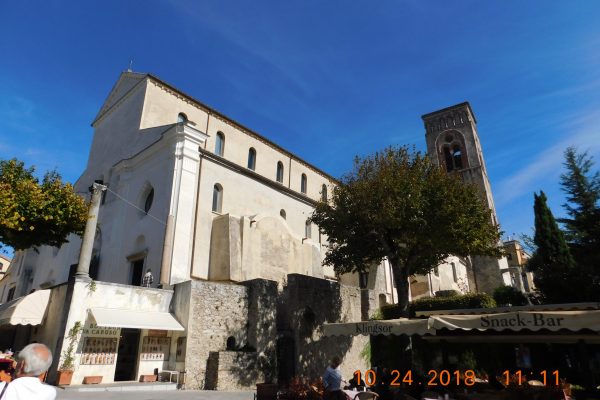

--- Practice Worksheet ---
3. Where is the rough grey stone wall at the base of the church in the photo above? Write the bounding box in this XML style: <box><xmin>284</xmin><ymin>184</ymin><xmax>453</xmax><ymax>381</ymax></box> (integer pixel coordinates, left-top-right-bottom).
<box><xmin>183</xmin><ymin>274</ymin><xmax>378</xmax><ymax>390</ymax></box>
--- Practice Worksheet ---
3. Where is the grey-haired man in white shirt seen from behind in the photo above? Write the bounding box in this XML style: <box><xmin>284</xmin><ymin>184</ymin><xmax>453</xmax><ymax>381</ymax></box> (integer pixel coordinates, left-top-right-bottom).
<box><xmin>0</xmin><ymin>343</ymin><xmax>56</xmax><ymax>400</ymax></box>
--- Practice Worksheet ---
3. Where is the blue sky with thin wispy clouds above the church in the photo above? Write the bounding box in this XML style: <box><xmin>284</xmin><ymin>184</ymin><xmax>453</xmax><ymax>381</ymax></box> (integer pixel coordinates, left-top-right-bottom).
<box><xmin>0</xmin><ymin>0</ymin><xmax>600</xmax><ymax>256</ymax></box>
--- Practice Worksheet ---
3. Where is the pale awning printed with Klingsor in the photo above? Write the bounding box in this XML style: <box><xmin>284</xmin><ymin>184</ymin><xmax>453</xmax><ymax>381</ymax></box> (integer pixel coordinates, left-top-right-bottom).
<box><xmin>323</xmin><ymin>318</ymin><xmax>435</xmax><ymax>336</ymax></box>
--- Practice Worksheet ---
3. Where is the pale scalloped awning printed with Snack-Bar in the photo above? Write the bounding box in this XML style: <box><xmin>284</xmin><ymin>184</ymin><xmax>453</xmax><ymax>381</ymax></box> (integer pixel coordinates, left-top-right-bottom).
<box><xmin>430</xmin><ymin>310</ymin><xmax>600</xmax><ymax>332</ymax></box>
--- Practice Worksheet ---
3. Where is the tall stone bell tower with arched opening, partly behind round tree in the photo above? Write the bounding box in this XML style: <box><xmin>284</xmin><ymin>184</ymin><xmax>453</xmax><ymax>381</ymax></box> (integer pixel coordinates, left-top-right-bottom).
<box><xmin>421</xmin><ymin>102</ymin><xmax>511</xmax><ymax>294</ymax></box>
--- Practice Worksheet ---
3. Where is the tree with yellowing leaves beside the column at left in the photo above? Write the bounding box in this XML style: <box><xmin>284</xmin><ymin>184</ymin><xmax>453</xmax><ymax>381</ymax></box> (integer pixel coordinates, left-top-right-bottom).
<box><xmin>0</xmin><ymin>159</ymin><xmax>87</xmax><ymax>250</ymax></box>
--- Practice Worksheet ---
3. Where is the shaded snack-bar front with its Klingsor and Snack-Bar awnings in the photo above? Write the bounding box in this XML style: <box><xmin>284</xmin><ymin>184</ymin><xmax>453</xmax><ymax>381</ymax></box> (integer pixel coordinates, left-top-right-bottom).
<box><xmin>324</xmin><ymin>303</ymin><xmax>600</xmax><ymax>394</ymax></box>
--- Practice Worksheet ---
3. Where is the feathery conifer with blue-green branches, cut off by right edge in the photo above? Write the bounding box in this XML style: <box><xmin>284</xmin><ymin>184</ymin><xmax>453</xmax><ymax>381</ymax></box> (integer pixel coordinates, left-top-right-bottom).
<box><xmin>559</xmin><ymin>147</ymin><xmax>600</xmax><ymax>296</ymax></box>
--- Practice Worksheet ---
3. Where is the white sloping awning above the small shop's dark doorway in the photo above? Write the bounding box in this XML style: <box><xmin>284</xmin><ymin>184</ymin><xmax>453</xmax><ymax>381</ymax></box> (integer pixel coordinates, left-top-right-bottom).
<box><xmin>91</xmin><ymin>308</ymin><xmax>184</xmax><ymax>331</ymax></box>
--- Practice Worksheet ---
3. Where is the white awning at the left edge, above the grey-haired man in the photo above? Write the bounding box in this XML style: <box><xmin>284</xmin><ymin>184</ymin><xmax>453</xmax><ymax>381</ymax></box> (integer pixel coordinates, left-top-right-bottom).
<box><xmin>0</xmin><ymin>289</ymin><xmax>50</xmax><ymax>325</ymax></box>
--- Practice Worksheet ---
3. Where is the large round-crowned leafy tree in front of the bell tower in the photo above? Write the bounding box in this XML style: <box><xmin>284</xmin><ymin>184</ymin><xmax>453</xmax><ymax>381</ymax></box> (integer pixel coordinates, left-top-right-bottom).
<box><xmin>312</xmin><ymin>147</ymin><xmax>501</xmax><ymax>315</ymax></box>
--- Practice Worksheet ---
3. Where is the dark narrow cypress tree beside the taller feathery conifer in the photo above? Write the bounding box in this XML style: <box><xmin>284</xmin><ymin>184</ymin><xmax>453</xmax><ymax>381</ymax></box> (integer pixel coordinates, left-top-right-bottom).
<box><xmin>528</xmin><ymin>192</ymin><xmax>581</xmax><ymax>303</ymax></box>
